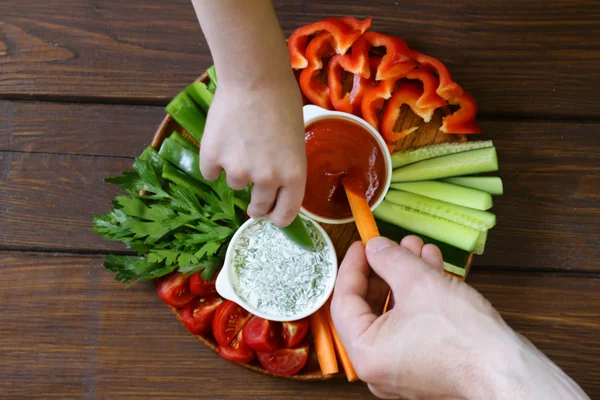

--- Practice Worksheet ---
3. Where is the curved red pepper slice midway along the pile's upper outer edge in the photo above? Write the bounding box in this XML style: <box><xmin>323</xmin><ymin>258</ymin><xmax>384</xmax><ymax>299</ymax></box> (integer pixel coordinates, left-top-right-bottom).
<box><xmin>362</xmin><ymin>32</ymin><xmax>415</xmax><ymax>81</ymax></box>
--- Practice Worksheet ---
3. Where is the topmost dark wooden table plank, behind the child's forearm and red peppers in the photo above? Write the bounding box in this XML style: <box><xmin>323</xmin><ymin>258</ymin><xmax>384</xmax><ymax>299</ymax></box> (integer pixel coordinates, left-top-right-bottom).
<box><xmin>0</xmin><ymin>0</ymin><xmax>600</xmax><ymax>117</ymax></box>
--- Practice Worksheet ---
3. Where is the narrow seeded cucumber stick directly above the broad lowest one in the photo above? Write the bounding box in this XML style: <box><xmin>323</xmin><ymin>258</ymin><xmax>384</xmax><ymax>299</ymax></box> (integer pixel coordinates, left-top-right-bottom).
<box><xmin>385</xmin><ymin>190</ymin><xmax>496</xmax><ymax>231</ymax></box>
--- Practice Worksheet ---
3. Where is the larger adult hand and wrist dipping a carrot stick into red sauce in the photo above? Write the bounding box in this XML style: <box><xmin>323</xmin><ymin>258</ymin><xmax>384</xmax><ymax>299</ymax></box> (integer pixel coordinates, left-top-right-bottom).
<box><xmin>331</xmin><ymin>236</ymin><xmax>588</xmax><ymax>399</ymax></box>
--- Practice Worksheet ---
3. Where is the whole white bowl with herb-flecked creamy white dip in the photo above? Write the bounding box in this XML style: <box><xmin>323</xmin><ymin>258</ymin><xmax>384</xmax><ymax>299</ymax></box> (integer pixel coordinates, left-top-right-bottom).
<box><xmin>216</xmin><ymin>217</ymin><xmax>338</xmax><ymax>321</ymax></box>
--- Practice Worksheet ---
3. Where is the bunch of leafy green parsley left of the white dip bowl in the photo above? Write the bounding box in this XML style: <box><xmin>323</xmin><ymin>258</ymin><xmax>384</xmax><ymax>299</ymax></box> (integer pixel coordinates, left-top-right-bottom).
<box><xmin>92</xmin><ymin>149</ymin><xmax>248</xmax><ymax>283</ymax></box>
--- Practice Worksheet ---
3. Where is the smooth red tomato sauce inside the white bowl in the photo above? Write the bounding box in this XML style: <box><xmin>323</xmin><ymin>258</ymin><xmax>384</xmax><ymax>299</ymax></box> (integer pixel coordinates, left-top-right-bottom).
<box><xmin>302</xmin><ymin>118</ymin><xmax>386</xmax><ymax>219</ymax></box>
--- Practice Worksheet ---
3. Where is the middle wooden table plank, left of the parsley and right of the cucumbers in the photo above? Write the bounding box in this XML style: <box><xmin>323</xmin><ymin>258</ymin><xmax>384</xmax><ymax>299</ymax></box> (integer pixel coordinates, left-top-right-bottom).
<box><xmin>0</xmin><ymin>121</ymin><xmax>600</xmax><ymax>271</ymax></box>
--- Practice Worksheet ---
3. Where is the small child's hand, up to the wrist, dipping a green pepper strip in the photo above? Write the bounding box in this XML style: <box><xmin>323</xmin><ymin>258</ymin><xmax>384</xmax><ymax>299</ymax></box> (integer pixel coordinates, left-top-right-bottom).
<box><xmin>200</xmin><ymin>75</ymin><xmax>306</xmax><ymax>226</ymax></box>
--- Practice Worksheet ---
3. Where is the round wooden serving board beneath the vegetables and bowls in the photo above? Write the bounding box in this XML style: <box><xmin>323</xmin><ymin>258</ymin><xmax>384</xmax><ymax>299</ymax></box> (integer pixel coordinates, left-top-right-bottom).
<box><xmin>151</xmin><ymin>73</ymin><xmax>472</xmax><ymax>381</ymax></box>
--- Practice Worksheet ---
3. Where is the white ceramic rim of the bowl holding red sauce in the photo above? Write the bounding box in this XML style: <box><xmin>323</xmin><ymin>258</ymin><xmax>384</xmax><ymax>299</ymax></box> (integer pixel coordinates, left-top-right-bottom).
<box><xmin>300</xmin><ymin>105</ymin><xmax>392</xmax><ymax>224</ymax></box>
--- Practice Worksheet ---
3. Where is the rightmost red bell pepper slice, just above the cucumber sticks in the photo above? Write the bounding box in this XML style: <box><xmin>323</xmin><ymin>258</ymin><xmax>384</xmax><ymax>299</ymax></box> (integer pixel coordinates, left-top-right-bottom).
<box><xmin>410</xmin><ymin>51</ymin><xmax>481</xmax><ymax>134</ymax></box>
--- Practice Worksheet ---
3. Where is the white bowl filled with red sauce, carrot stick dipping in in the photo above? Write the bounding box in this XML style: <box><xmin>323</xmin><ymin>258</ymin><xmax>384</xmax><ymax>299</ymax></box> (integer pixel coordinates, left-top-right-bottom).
<box><xmin>300</xmin><ymin>105</ymin><xmax>392</xmax><ymax>224</ymax></box>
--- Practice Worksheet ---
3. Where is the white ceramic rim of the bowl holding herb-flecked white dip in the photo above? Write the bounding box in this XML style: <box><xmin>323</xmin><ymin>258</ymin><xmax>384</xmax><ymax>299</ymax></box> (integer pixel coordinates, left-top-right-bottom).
<box><xmin>216</xmin><ymin>216</ymin><xmax>338</xmax><ymax>321</ymax></box>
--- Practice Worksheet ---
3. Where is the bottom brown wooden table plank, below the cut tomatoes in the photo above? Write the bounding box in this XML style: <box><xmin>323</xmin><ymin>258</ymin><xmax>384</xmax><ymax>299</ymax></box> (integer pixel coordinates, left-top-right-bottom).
<box><xmin>0</xmin><ymin>252</ymin><xmax>600</xmax><ymax>400</ymax></box>
